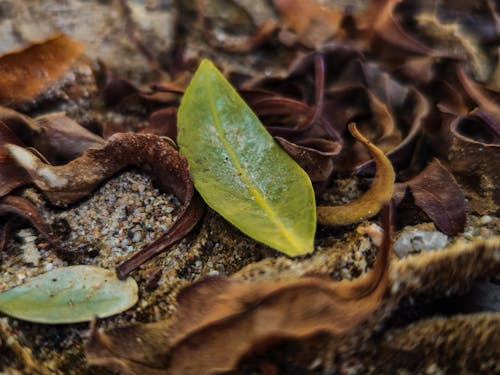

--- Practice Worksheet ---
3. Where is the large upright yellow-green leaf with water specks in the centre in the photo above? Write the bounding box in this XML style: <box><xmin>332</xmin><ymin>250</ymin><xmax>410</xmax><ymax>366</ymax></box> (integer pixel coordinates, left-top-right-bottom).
<box><xmin>177</xmin><ymin>60</ymin><xmax>316</xmax><ymax>256</ymax></box>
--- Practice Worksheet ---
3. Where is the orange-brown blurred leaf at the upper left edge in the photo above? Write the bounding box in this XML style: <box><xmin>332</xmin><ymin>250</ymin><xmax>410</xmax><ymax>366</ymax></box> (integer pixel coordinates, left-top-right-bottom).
<box><xmin>0</xmin><ymin>34</ymin><xmax>83</xmax><ymax>105</ymax></box>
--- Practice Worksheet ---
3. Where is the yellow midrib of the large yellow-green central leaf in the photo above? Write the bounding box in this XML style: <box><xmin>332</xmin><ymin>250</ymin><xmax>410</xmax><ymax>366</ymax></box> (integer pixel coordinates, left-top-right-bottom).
<box><xmin>208</xmin><ymin>92</ymin><xmax>300</xmax><ymax>251</ymax></box>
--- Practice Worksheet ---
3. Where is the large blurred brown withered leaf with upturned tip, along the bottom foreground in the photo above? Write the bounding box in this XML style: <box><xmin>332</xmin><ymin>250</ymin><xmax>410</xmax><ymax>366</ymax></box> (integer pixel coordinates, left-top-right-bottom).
<box><xmin>87</xmin><ymin>208</ymin><xmax>391</xmax><ymax>375</ymax></box>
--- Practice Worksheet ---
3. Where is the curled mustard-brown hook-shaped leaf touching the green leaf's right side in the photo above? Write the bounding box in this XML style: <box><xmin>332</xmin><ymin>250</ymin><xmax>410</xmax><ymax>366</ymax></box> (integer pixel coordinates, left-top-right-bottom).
<box><xmin>317</xmin><ymin>124</ymin><xmax>395</xmax><ymax>225</ymax></box>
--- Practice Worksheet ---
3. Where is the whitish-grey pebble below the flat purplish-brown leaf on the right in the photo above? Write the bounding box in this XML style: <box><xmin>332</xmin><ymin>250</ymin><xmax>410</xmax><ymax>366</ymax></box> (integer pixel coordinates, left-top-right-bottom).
<box><xmin>394</xmin><ymin>229</ymin><xmax>448</xmax><ymax>258</ymax></box>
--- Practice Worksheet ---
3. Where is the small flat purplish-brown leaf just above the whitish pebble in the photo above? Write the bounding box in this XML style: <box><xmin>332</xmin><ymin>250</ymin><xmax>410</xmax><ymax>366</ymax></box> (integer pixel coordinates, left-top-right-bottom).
<box><xmin>408</xmin><ymin>159</ymin><xmax>466</xmax><ymax>236</ymax></box>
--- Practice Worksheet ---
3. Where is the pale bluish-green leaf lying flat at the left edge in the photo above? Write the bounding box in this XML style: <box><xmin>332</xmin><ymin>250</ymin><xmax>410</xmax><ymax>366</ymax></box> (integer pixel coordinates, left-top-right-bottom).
<box><xmin>0</xmin><ymin>266</ymin><xmax>138</xmax><ymax>324</ymax></box>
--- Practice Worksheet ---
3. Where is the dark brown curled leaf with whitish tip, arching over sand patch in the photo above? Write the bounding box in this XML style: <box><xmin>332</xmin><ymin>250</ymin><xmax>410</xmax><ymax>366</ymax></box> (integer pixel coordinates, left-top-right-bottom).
<box><xmin>5</xmin><ymin>133</ymin><xmax>203</xmax><ymax>277</ymax></box>
